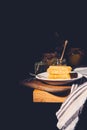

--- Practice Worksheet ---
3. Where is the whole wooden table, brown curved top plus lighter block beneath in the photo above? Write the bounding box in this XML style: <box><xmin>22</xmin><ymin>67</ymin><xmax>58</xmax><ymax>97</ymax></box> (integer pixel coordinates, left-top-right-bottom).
<box><xmin>23</xmin><ymin>79</ymin><xmax>71</xmax><ymax>103</ymax></box>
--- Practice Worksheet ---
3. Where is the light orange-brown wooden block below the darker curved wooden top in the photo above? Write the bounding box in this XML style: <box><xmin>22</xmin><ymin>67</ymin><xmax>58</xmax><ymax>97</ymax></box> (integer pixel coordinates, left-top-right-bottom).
<box><xmin>33</xmin><ymin>89</ymin><xmax>67</xmax><ymax>103</ymax></box>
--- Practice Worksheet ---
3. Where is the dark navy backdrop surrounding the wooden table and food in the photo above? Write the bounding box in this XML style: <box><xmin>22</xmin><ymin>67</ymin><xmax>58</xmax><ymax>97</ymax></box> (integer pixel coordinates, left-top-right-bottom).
<box><xmin>2</xmin><ymin>0</ymin><xmax>87</xmax><ymax>130</ymax></box>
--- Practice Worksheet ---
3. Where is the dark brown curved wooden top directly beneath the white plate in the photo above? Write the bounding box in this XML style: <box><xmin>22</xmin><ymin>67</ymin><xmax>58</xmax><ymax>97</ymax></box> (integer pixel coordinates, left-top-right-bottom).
<box><xmin>22</xmin><ymin>79</ymin><xmax>71</xmax><ymax>92</ymax></box>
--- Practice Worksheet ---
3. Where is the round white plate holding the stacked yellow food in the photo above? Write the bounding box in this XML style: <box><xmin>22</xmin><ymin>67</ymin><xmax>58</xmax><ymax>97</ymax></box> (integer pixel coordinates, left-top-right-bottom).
<box><xmin>36</xmin><ymin>71</ymin><xmax>82</xmax><ymax>85</ymax></box>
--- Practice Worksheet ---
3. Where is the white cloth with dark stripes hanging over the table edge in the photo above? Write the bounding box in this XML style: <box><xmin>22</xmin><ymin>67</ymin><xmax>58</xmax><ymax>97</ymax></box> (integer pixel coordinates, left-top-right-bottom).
<box><xmin>56</xmin><ymin>82</ymin><xmax>87</xmax><ymax>130</ymax></box>
